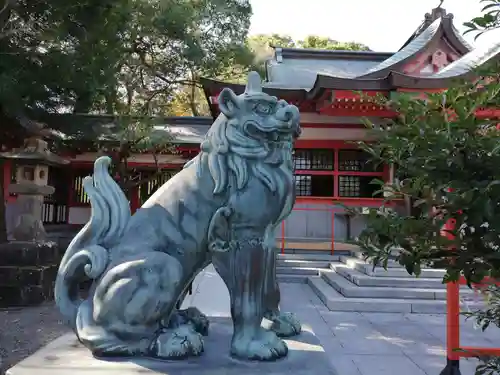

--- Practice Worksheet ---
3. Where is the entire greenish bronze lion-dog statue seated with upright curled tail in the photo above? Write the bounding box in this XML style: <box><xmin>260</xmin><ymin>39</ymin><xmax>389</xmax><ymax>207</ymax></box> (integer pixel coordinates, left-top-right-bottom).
<box><xmin>55</xmin><ymin>72</ymin><xmax>301</xmax><ymax>360</ymax></box>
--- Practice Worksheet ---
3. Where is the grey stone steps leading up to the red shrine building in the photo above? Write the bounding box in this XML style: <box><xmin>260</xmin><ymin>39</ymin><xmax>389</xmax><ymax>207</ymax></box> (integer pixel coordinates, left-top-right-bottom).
<box><xmin>277</xmin><ymin>252</ymin><xmax>481</xmax><ymax>314</ymax></box>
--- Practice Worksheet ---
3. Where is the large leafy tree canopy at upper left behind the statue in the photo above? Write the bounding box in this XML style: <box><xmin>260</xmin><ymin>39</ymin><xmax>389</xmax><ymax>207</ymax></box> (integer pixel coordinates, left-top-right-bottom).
<box><xmin>0</xmin><ymin>0</ymin><xmax>253</xmax><ymax>241</ymax></box>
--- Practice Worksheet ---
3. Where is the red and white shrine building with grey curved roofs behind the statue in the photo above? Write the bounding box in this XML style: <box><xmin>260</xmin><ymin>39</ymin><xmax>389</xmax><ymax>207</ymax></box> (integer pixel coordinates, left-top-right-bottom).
<box><xmin>0</xmin><ymin>8</ymin><xmax>500</xmax><ymax>250</ymax></box>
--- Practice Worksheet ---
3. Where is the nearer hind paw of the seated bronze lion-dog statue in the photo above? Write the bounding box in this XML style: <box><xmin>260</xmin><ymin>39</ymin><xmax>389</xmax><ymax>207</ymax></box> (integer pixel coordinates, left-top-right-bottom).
<box><xmin>153</xmin><ymin>324</ymin><xmax>204</xmax><ymax>359</ymax></box>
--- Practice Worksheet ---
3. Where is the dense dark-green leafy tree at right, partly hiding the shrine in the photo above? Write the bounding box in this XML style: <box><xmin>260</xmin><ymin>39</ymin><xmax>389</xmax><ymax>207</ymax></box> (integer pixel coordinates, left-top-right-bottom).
<box><xmin>357</xmin><ymin>64</ymin><xmax>500</xmax><ymax>374</ymax></box>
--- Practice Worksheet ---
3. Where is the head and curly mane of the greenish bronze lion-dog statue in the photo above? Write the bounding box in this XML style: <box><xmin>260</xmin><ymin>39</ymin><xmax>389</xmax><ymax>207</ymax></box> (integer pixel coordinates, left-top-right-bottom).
<box><xmin>201</xmin><ymin>72</ymin><xmax>301</xmax><ymax>194</ymax></box>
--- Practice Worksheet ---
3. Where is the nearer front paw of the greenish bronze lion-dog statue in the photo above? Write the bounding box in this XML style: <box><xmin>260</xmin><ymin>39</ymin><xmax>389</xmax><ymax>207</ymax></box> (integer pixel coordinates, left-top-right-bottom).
<box><xmin>231</xmin><ymin>328</ymin><xmax>288</xmax><ymax>361</ymax></box>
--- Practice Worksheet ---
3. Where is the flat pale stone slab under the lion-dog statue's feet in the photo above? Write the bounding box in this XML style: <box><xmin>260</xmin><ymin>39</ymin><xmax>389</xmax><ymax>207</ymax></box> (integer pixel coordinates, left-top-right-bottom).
<box><xmin>6</xmin><ymin>318</ymin><xmax>336</xmax><ymax>375</ymax></box>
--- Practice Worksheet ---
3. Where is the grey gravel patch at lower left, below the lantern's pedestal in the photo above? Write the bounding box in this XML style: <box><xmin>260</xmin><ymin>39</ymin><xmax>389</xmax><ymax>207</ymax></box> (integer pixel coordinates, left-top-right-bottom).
<box><xmin>0</xmin><ymin>303</ymin><xmax>69</xmax><ymax>375</ymax></box>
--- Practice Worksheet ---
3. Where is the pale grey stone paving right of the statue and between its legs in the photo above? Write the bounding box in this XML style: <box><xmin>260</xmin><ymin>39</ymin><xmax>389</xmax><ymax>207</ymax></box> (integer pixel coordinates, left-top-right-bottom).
<box><xmin>188</xmin><ymin>268</ymin><xmax>500</xmax><ymax>375</ymax></box>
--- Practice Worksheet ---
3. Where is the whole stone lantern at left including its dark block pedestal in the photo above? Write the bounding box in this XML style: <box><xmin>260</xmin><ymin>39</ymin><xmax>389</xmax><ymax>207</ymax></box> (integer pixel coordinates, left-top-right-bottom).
<box><xmin>0</xmin><ymin>138</ymin><xmax>68</xmax><ymax>307</ymax></box>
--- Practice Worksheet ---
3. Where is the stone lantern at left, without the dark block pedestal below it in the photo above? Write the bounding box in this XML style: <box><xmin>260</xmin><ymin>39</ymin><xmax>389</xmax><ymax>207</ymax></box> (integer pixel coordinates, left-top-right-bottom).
<box><xmin>0</xmin><ymin>138</ymin><xmax>68</xmax><ymax>242</ymax></box>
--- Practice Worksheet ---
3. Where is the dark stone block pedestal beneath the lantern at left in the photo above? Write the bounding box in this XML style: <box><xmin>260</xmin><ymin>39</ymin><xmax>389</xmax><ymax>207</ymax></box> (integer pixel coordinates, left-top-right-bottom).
<box><xmin>0</xmin><ymin>241</ymin><xmax>61</xmax><ymax>308</ymax></box>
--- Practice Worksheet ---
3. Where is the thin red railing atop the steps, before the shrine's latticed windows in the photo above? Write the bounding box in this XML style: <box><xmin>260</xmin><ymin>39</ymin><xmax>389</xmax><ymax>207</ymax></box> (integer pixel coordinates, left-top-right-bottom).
<box><xmin>279</xmin><ymin>197</ymin><xmax>395</xmax><ymax>255</ymax></box>
